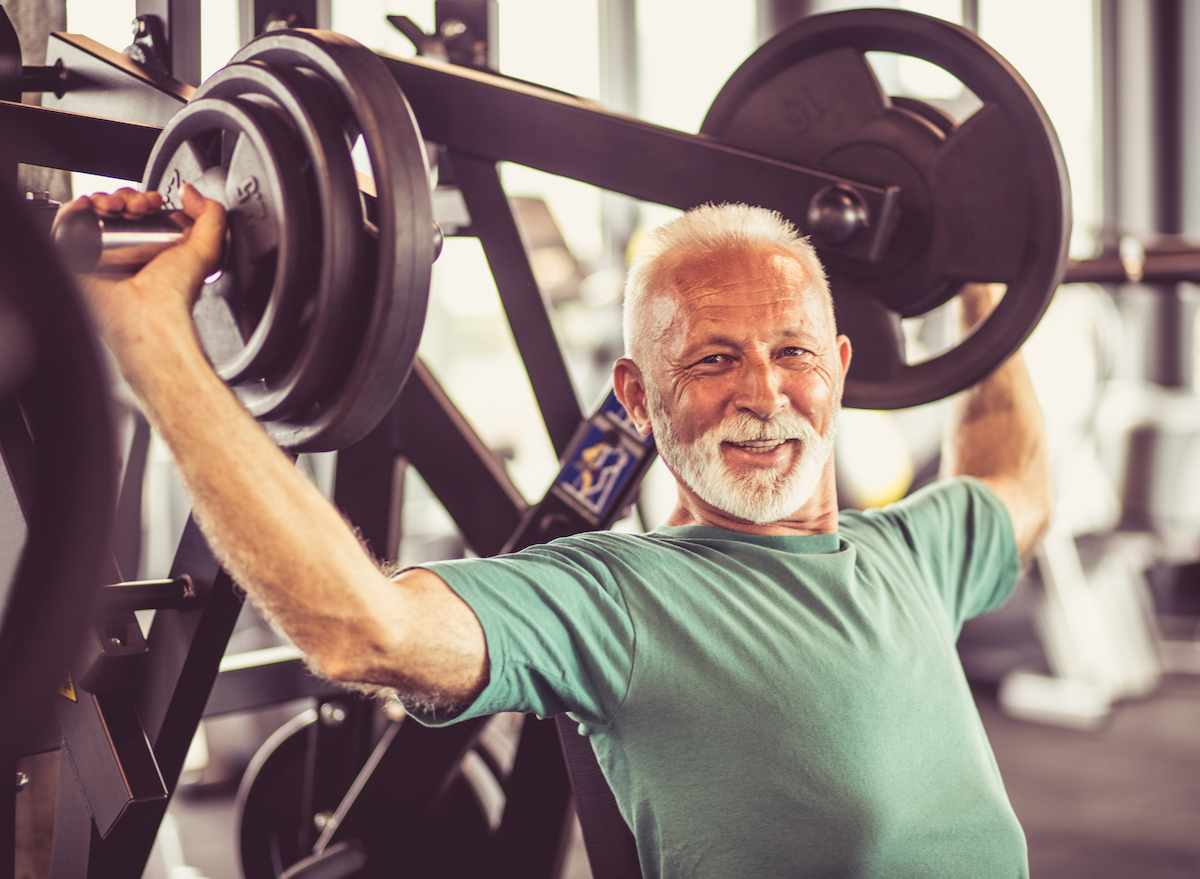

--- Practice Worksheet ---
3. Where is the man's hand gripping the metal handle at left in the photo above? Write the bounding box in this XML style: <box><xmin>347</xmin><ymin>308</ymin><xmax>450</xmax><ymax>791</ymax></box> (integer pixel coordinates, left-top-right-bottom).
<box><xmin>55</xmin><ymin>184</ymin><xmax>224</xmax><ymax>353</ymax></box>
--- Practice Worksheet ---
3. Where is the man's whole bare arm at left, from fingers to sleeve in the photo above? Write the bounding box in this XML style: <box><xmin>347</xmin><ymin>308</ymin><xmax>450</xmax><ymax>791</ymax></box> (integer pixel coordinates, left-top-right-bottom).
<box><xmin>72</xmin><ymin>189</ymin><xmax>487</xmax><ymax>707</ymax></box>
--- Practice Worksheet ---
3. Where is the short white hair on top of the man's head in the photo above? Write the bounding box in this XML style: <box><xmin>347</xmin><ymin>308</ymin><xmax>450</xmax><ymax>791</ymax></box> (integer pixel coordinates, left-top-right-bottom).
<box><xmin>624</xmin><ymin>204</ymin><xmax>833</xmax><ymax>363</ymax></box>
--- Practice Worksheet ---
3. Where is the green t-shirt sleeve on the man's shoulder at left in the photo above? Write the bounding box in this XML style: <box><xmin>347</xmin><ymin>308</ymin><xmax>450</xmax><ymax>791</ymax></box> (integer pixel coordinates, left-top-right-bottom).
<box><xmin>414</xmin><ymin>543</ymin><xmax>634</xmax><ymax>725</ymax></box>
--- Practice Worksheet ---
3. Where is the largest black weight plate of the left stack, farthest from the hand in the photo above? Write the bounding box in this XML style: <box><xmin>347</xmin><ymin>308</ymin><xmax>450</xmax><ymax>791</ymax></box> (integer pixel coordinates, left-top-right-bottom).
<box><xmin>226</xmin><ymin>29</ymin><xmax>433</xmax><ymax>452</ymax></box>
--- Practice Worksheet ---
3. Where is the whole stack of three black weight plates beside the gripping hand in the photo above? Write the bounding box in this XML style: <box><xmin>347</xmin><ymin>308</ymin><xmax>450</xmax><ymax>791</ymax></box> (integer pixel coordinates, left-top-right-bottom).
<box><xmin>143</xmin><ymin>30</ymin><xmax>436</xmax><ymax>452</ymax></box>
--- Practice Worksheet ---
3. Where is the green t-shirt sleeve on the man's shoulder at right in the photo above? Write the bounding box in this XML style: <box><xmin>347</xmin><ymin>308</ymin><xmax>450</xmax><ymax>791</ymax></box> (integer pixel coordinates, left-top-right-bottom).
<box><xmin>849</xmin><ymin>477</ymin><xmax>1020</xmax><ymax>632</ymax></box>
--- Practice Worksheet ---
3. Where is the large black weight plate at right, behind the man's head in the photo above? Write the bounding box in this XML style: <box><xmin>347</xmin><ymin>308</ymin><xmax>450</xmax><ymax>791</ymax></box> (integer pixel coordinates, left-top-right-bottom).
<box><xmin>701</xmin><ymin>10</ymin><xmax>1070</xmax><ymax>408</ymax></box>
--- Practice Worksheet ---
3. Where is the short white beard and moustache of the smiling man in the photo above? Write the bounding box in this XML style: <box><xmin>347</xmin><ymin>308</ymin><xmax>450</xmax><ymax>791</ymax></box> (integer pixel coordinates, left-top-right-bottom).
<box><xmin>647</xmin><ymin>388</ymin><xmax>836</xmax><ymax>525</ymax></box>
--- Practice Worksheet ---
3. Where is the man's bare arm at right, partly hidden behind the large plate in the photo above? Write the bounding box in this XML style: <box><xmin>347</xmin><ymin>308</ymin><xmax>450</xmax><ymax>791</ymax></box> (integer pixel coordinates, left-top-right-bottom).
<box><xmin>942</xmin><ymin>285</ymin><xmax>1054</xmax><ymax>561</ymax></box>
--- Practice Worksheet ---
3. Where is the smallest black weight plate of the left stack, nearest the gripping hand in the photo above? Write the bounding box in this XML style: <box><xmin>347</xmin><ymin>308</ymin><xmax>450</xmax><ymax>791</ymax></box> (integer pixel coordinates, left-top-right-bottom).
<box><xmin>143</xmin><ymin>97</ymin><xmax>314</xmax><ymax>417</ymax></box>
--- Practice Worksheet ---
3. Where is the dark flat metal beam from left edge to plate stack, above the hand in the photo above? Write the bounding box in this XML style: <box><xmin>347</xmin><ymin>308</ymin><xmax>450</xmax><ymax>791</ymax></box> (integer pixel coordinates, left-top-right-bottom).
<box><xmin>0</xmin><ymin>101</ymin><xmax>162</xmax><ymax>180</ymax></box>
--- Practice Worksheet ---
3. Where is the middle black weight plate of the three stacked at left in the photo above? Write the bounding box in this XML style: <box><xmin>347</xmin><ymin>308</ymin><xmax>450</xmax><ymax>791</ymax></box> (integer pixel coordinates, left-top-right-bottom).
<box><xmin>192</xmin><ymin>61</ymin><xmax>366</xmax><ymax>429</ymax></box>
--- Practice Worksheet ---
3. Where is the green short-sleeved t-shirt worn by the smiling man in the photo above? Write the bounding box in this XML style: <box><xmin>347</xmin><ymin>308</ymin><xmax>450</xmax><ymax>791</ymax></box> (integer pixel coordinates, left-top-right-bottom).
<box><xmin>417</xmin><ymin>479</ymin><xmax>1027</xmax><ymax>879</ymax></box>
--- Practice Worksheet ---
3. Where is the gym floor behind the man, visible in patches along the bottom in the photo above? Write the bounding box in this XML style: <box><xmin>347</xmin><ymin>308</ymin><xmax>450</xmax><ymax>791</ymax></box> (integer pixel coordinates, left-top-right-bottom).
<box><xmin>157</xmin><ymin>675</ymin><xmax>1200</xmax><ymax>879</ymax></box>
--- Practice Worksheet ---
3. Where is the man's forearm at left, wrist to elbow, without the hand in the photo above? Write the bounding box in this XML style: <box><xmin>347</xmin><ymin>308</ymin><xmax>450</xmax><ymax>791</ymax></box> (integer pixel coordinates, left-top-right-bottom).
<box><xmin>119</xmin><ymin>319</ymin><xmax>398</xmax><ymax>668</ymax></box>
